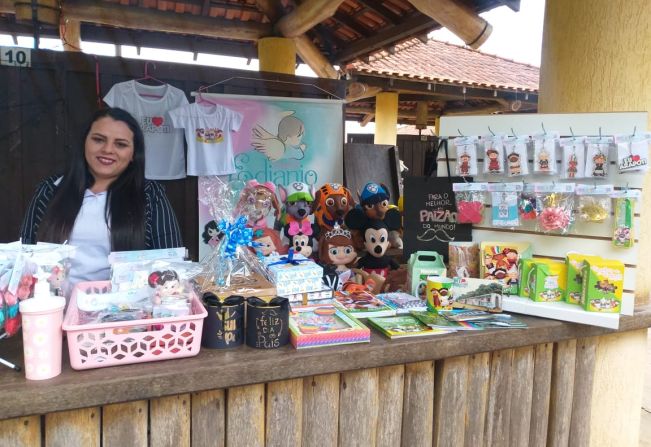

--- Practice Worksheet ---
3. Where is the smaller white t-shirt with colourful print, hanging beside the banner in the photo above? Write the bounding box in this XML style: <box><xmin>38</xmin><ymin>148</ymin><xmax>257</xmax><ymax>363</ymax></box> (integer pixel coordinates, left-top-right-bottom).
<box><xmin>170</xmin><ymin>103</ymin><xmax>242</xmax><ymax>175</ymax></box>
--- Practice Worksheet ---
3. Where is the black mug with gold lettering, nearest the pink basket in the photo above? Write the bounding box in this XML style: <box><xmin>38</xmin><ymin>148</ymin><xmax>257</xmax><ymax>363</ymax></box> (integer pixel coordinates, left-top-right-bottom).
<box><xmin>201</xmin><ymin>292</ymin><xmax>244</xmax><ymax>349</ymax></box>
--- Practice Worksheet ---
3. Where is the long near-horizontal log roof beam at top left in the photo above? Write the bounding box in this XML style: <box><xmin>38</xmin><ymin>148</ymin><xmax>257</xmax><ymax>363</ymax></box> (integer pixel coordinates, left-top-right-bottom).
<box><xmin>0</xmin><ymin>0</ymin><xmax>271</xmax><ymax>41</ymax></box>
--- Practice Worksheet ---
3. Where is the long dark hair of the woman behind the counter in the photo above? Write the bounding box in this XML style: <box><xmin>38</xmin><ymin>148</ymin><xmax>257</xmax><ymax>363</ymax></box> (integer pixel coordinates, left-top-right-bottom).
<box><xmin>39</xmin><ymin>108</ymin><xmax>145</xmax><ymax>251</ymax></box>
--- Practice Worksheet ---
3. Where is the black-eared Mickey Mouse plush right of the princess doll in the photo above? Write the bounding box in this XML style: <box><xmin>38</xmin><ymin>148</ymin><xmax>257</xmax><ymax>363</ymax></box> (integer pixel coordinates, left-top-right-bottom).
<box><xmin>345</xmin><ymin>208</ymin><xmax>400</xmax><ymax>278</ymax></box>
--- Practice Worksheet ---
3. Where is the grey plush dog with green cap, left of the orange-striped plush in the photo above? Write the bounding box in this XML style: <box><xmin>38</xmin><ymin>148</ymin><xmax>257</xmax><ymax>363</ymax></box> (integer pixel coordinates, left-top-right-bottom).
<box><xmin>277</xmin><ymin>182</ymin><xmax>318</xmax><ymax>239</ymax></box>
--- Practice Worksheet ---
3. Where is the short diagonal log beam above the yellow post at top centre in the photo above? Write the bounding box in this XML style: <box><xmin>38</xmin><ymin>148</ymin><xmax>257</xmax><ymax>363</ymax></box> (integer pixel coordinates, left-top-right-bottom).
<box><xmin>274</xmin><ymin>0</ymin><xmax>343</xmax><ymax>37</ymax></box>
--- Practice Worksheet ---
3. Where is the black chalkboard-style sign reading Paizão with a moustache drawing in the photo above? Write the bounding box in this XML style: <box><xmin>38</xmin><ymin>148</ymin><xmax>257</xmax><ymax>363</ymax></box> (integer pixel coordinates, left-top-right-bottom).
<box><xmin>403</xmin><ymin>140</ymin><xmax>472</xmax><ymax>261</ymax></box>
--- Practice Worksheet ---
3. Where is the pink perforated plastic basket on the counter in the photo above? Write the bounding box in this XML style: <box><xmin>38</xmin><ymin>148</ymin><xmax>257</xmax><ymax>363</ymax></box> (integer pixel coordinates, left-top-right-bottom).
<box><xmin>63</xmin><ymin>281</ymin><xmax>208</xmax><ymax>369</ymax></box>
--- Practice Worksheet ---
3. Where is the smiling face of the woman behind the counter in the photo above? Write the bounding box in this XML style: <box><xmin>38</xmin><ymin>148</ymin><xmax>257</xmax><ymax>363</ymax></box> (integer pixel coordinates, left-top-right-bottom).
<box><xmin>84</xmin><ymin>116</ymin><xmax>134</xmax><ymax>192</ymax></box>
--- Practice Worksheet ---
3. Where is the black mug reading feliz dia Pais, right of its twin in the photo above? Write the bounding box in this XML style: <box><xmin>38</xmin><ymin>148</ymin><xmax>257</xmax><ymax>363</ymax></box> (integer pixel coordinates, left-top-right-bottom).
<box><xmin>246</xmin><ymin>296</ymin><xmax>289</xmax><ymax>349</ymax></box>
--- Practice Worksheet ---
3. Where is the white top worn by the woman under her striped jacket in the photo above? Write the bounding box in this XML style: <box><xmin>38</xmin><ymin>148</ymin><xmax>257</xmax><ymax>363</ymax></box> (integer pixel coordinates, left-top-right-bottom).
<box><xmin>68</xmin><ymin>189</ymin><xmax>111</xmax><ymax>286</ymax></box>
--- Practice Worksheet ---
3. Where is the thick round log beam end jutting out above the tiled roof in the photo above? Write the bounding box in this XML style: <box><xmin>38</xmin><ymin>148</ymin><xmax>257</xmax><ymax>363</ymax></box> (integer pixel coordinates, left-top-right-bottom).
<box><xmin>410</xmin><ymin>0</ymin><xmax>493</xmax><ymax>49</ymax></box>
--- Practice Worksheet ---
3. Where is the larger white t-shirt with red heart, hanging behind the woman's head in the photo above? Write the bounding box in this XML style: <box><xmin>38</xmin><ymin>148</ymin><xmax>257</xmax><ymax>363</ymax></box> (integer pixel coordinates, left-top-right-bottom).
<box><xmin>104</xmin><ymin>81</ymin><xmax>188</xmax><ymax>180</ymax></box>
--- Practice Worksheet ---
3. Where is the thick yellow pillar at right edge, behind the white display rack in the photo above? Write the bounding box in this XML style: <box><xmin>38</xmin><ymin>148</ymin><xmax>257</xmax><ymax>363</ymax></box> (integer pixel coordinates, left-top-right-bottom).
<box><xmin>538</xmin><ymin>0</ymin><xmax>651</xmax><ymax>446</ymax></box>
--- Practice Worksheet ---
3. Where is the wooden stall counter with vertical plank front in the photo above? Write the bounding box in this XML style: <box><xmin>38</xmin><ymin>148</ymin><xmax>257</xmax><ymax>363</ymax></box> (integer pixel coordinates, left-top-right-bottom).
<box><xmin>0</xmin><ymin>305</ymin><xmax>651</xmax><ymax>446</ymax></box>
